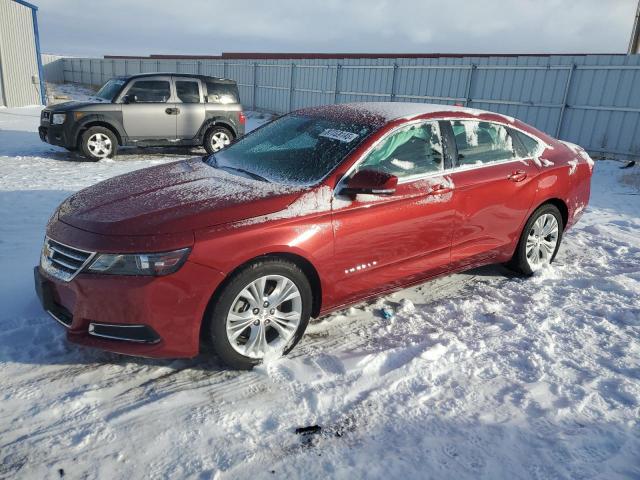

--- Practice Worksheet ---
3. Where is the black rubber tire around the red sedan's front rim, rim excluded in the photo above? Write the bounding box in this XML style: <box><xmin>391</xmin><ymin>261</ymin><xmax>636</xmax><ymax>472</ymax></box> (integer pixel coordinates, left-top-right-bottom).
<box><xmin>203</xmin><ymin>258</ymin><xmax>313</xmax><ymax>370</ymax></box>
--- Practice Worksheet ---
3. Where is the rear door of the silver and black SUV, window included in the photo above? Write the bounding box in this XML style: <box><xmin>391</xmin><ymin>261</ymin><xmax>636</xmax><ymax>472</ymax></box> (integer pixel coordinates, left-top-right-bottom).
<box><xmin>173</xmin><ymin>77</ymin><xmax>205</xmax><ymax>139</ymax></box>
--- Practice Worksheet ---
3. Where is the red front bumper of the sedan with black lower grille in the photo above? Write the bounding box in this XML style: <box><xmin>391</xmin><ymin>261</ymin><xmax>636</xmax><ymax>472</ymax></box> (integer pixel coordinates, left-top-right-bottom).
<box><xmin>34</xmin><ymin>261</ymin><xmax>224</xmax><ymax>358</ymax></box>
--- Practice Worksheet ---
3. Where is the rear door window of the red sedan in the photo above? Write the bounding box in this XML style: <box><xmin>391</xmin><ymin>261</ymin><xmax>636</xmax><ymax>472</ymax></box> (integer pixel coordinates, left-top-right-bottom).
<box><xmin>451</xmin><ymin>120</ymin><xmax>515</xmax><ymax>165</ymax></box>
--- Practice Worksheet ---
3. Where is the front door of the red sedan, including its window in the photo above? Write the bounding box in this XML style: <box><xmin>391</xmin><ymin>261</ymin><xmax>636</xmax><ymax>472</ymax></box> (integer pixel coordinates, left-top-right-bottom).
<box><xmin>333</xmin><ymin>122</ymin><xmax>454</xmax><ymax>303</ymax></box>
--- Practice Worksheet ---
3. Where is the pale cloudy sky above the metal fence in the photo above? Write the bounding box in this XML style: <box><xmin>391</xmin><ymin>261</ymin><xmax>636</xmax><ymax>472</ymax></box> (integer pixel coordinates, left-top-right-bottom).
<box><xmin>34</xmin><ymin>0</ymin><xmax>637</xmax><ymax>56</ymax></box>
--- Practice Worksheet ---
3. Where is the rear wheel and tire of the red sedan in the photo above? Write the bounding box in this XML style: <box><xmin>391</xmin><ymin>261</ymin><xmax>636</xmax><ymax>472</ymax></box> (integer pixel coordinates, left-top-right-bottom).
<box><xmin>507</xmin><ymin>203</ymin><xmax>564</xmax><ymax>276</ymax></box>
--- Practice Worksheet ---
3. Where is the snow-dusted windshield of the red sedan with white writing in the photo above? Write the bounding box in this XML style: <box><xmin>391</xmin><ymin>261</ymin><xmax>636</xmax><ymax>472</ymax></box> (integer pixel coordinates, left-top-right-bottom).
<box><xmin>207</xmin><ymin>115</ymin><xmax>373</xmax><ymax>185</ymax></box>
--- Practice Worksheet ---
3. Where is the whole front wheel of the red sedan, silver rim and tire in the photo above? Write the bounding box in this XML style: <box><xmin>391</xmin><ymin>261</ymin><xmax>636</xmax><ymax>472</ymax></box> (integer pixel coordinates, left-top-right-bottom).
<box><xmin>204</xmin><ymin>259</ymin><xmax>313</xmax><ymax>370</ymax></box>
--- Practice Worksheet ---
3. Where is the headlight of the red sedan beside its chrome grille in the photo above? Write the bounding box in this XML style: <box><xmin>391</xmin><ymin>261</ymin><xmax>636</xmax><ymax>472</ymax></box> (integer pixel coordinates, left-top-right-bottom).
<box><xmin>87</xmin><ymin>248</ymin><xmax>191</xmax><ymax>276</ymax></box>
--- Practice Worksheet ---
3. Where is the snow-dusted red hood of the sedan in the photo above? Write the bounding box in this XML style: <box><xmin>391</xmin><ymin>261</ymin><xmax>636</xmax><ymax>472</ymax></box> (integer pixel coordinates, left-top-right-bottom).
<box><xmin>58</xmin><ymin>159</ymin><xmax>303</xmax><ymax>235</ymax></box>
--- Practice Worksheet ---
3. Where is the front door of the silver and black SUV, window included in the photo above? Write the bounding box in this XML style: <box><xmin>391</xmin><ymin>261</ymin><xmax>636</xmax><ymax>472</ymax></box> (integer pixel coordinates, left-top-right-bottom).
<box><xmin>119</xmin><ymin>76</ymin><xmax>177</xmax><ymax>141</ymax></box>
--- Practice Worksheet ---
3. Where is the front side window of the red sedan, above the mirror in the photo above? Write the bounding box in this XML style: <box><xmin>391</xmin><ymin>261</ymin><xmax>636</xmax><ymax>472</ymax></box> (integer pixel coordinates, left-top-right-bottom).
<box><xmin>358</xmin><ymin>122</ymin><xmax>444</xmax><ymax>178</ymax></box>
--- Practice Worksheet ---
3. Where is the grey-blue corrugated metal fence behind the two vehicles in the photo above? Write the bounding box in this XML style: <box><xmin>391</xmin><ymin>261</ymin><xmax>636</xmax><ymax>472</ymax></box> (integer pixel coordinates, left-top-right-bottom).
<box><xmin>43</xmin><ymin>55</ymin><xmax>640</xmax><ymax>157</ymax></box>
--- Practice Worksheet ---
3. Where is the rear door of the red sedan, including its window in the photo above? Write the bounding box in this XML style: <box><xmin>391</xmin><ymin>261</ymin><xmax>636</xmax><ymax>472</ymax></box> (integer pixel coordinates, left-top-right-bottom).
<box><xmin>443</xmin><ymin>120</ymin><xmax>538</xmax><ymax>268</ymax></box>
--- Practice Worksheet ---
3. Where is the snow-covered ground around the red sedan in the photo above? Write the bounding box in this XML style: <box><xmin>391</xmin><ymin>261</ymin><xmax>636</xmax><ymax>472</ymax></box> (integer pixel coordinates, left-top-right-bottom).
<box><xmin>0</xmin><ymin>89</ymin><xmax>640</xmax><ymax>479</ymax></box>
